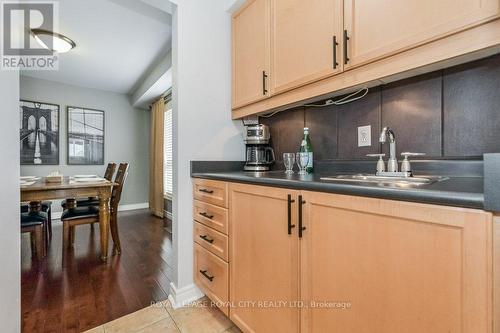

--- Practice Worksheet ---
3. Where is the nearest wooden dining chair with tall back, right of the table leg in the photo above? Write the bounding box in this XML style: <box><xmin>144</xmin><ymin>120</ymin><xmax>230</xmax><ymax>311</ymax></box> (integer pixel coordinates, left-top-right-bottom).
<box><xmin>61</xmin><ymin>163</ymin><xmax>129</xmax><ymax>254</ymax></box>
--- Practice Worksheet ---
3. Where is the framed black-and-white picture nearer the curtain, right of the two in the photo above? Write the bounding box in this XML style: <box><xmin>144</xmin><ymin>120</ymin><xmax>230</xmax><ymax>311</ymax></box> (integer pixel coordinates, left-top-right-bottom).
<box><xmin>67</xmin><ymin>106</ymin><xmax>104</xmax><ymax>165</ymax></box>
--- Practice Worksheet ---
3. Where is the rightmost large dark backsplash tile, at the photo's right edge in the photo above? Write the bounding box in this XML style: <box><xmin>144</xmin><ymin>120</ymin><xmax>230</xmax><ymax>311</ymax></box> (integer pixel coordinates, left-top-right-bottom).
<box><xmin>443</xmin><ymin>56</ymin><xmax>500</xmax><ymax>156</ymax></box>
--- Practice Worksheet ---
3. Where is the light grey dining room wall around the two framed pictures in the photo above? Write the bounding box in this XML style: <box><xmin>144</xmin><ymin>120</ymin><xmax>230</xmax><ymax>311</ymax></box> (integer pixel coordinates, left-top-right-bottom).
<box><xmin>17</xmin><ymin>76</ymin><xmax>150</xmax><ymax>211</ymax></box>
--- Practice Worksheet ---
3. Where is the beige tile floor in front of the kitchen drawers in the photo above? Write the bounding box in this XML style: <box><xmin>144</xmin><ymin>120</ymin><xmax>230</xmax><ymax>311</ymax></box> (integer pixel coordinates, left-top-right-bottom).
<box><xmin>87</xmin><ymin>297</ymin><xmax>241</xmax><ymax>333</ymax></box>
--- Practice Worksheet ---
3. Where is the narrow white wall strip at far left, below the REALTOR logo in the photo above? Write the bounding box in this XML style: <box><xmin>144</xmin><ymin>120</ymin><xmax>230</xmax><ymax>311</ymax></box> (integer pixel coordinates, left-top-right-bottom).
<box><xmin>0</xmin><ymin>70</ymin><xmax>21</xmax><ymax>333</ymax></box>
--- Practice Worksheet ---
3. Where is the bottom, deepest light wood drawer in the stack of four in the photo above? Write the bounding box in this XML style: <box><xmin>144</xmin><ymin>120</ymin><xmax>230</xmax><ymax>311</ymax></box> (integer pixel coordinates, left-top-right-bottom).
<box><xmin>194</xmin><ymin>243</ymin><xmax>229</xmax><ymax>315</ymax></box>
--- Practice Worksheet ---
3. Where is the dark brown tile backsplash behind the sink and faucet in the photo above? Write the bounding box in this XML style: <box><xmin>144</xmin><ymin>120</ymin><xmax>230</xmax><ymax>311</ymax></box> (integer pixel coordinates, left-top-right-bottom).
<box><xmin>260</xmin><ymin>54</ymin><xmax>500</xmax><ymax>160</ymax></box>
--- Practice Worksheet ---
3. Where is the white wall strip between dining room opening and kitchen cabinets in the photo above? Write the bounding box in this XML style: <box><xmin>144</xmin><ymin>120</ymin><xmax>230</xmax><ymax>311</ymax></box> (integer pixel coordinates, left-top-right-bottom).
<box><xmin>172</xmin><ymin>0</ymin><xmax>244</xmax><ymax>300</ymax></box>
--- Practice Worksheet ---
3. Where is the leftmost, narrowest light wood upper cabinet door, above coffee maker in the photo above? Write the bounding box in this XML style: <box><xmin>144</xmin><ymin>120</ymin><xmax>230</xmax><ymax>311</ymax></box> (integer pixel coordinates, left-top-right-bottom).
<box><xmin>232</xmin><ymin>0</ymin><xmax>271</xmax><ymax>108</ymax></box>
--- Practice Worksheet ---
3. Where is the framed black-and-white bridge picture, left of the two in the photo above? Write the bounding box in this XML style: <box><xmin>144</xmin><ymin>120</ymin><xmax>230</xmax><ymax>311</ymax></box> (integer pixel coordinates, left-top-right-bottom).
<box><xmin>19</xmin><ymin>100</ymin><xmax>59</xmax><ymax>165</ymax></box>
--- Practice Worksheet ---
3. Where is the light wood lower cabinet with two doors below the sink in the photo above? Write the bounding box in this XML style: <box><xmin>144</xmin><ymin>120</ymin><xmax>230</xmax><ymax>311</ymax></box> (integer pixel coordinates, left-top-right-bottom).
<box><xmin>229</xmin><ymin>183</ymin><xmax>498</xmax><ymax>333</ymax></box>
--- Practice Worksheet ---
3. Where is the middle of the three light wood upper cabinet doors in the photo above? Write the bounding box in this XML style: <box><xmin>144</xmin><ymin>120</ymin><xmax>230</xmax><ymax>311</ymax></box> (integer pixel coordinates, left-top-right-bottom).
<box><xmin>271</xmin><ymin>0</ymin><xmax>343</xmax><ymax>92</ymax></box>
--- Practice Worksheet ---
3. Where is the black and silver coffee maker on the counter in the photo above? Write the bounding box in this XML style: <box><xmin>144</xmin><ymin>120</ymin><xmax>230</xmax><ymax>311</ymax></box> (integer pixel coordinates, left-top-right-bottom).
<box><xmin>243</xmin><ymin>124</ymin><xmax>275</xmax><ymax>171</ymax></box>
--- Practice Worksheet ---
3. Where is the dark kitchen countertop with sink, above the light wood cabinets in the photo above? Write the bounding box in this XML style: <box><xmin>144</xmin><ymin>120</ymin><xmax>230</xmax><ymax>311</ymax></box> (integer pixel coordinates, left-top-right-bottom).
<box><xmin>191</xmin><ymin>160</ymin><xmax>484</xmax><ymax>209</ymax></box>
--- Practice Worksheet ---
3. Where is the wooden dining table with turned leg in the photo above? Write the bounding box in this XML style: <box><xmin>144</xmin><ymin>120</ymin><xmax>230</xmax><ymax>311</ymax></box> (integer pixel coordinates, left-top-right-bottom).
<box><xmin>21</xmin><ymin>177</ymin><xmax>117</xmax><ymax>261</ymax></box>
